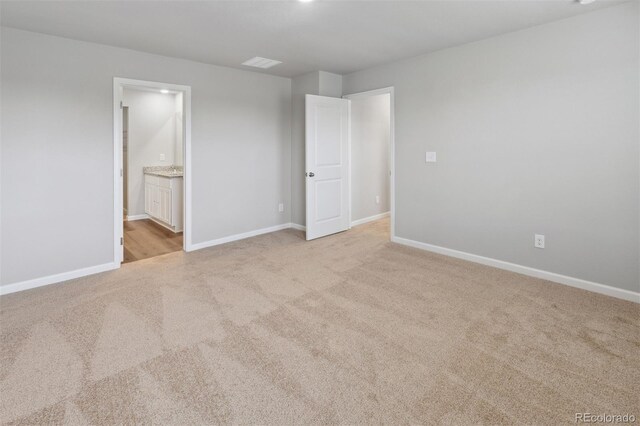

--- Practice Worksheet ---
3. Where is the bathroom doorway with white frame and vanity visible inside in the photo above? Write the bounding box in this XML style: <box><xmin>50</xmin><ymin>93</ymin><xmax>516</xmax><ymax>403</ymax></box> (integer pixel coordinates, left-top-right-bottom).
<box><xmin>114</xmin><ymin>78</ymin><xmax>191</xmax><ymax>264</ymax></box>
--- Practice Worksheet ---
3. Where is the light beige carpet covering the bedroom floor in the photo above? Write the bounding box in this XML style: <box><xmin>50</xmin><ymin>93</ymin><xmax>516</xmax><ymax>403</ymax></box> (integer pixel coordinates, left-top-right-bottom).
<box><xmin>0</xmin><ymin>221</ymin><xmax>640</xmax><ymax>425</ymax></box>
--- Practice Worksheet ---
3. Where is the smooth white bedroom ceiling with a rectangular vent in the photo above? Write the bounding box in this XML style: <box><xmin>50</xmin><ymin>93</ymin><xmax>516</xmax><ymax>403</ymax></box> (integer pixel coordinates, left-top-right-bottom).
<box><xmin>0</xmin><ymin>0</ymin><xmax>622</xmax><ymax>77</ymax></box>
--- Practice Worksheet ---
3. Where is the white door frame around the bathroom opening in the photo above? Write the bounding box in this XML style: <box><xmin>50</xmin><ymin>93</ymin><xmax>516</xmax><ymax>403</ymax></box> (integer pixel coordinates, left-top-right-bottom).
<box><xmin>113</xmin><ymin>77</ymin><xmax>193</xmax><ymax>267</ymax></box>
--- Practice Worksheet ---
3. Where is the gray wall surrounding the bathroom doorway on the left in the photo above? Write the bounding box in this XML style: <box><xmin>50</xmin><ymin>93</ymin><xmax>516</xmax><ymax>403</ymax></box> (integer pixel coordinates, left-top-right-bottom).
<box><xmin>0</xmin><ymin>28</ymin><xmax>291</xmax><ymax>285</ymax></box>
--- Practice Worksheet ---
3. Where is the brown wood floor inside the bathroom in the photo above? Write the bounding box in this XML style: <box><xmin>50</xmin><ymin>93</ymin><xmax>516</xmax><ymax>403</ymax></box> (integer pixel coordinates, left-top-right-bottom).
<box><xmin>122</xmin><ymin>219</ymin><xmax>182</xmax><ymax>263</ymax></box>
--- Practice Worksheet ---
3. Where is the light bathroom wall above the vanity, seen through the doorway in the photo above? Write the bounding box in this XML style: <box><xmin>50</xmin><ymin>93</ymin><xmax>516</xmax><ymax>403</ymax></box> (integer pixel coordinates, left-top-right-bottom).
<box><xmin>122</xmin><ymin>89</ymin><xmax>177</xmax><ymax>216</ymax></box>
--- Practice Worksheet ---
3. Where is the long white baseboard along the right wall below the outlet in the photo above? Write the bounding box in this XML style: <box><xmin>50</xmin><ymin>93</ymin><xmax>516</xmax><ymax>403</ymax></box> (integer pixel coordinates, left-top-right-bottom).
<box><xmin>391</xmin><ymin>237</ymin><xmax>640</xmax><ymax>303</ymax></box>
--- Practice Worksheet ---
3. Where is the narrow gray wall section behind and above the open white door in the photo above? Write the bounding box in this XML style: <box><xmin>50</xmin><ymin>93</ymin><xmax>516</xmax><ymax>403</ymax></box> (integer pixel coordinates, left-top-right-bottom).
<box><xmin>291</xmin><ymin>71</ymin><xmax>342</xmax><ymax>225</ymax></box>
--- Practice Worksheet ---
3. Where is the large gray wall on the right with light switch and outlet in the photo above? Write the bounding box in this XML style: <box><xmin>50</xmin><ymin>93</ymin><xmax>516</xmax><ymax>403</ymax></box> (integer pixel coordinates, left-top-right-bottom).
<box><xmin>343</xmin><ymin>2</ymin><xmax>640</xmax><ymax>291</ymax></box>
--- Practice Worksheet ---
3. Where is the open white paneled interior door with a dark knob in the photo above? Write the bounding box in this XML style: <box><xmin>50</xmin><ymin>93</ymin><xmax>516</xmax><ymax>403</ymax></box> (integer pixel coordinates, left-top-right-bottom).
<box><xmin>305</xmin><ymin>95</ymin><xmax>350</xmax><ymax>240</ymax></box>
